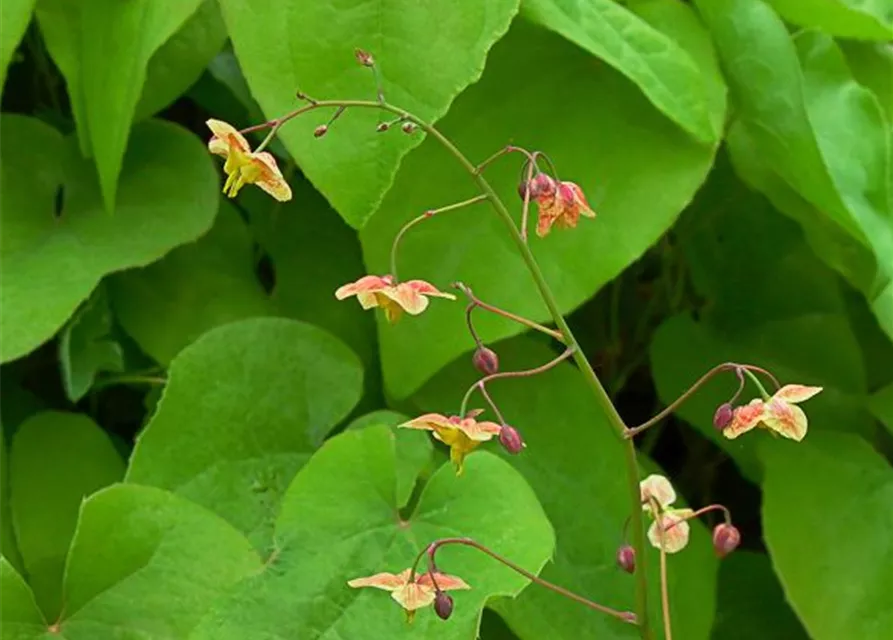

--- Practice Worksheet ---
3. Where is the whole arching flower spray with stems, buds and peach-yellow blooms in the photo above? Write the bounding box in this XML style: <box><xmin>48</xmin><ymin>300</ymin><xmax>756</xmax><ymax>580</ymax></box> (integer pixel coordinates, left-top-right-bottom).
<box><xmin>207</xmin><ymin>49</ymin><xmax>822</xmax><ymax>639</ymax></box>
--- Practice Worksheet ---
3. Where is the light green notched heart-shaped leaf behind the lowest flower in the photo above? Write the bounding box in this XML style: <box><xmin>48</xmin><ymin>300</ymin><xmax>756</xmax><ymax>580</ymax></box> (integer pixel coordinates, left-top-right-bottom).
<box><xmin>190</xmin><ymin>427</ymin><xmax>554</xmax><ymax>640</ymax></box>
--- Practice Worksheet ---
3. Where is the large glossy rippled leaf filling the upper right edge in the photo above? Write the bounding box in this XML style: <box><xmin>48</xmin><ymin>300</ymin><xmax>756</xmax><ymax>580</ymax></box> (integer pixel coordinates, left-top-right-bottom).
<box><xmin>696</xmin><ymin>0</ymin><xmax>893</xmax><ymax>336</ymax></box>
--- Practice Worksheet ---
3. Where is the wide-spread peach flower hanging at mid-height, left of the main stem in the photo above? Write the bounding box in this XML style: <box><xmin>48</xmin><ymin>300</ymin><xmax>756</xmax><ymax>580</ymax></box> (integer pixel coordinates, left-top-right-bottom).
<box><xmin>335</xmin><ymin>275</ymin><xmax>456</xmax><ymax>324</ymax></box>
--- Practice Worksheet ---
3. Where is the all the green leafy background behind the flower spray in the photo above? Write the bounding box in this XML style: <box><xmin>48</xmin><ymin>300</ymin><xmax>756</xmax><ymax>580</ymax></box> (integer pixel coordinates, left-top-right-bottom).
<box><xmin>0</xmin><ymin>0</ymin><xmax>893</xmax><ymax>640</ymax></box>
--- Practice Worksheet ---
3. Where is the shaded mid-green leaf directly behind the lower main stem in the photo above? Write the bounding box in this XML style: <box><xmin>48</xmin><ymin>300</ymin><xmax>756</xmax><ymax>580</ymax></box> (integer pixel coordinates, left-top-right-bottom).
<box><xmin>413</xmin><ymin>337</ymin><xmax>716</xmax><ymax>640</ymax></box>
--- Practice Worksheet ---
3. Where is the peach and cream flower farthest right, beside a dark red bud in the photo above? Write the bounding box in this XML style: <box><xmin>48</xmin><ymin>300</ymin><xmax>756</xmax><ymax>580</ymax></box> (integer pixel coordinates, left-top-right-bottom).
<box><xmin>722</xmin><ymin>384</ymin><xmax>822</xmax><ymax>442</ymax></box>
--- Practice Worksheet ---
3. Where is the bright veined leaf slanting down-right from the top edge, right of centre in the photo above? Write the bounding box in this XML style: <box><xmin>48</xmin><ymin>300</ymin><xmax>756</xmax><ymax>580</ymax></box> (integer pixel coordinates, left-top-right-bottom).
<box><xmin>522</xmin><ymin>0</ymin><xmax>725</xmax><ymax>144</ymax></box>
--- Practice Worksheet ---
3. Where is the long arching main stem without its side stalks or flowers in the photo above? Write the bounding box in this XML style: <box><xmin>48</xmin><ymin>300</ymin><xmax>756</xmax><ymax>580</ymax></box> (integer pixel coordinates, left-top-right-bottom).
<box><xmin>262</xmin><ymin>100</ymin><xmax>654</xmax><ymax>640</ymax></box>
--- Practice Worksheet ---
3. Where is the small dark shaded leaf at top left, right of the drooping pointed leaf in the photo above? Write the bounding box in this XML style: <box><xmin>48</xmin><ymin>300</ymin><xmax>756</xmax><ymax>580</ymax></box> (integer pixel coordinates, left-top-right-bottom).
<box><xmin>133</xmin><ymin>0</ymin><xmax>226</xmax><ymax>121</ymax></box>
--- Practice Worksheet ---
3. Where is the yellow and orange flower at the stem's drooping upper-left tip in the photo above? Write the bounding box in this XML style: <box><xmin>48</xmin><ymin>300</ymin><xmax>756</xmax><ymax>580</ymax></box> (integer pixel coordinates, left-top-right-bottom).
<box><xmin>206</xmin><ymin>118</ymin><xmax>291</xmax><ymax>202</ymax></box>
